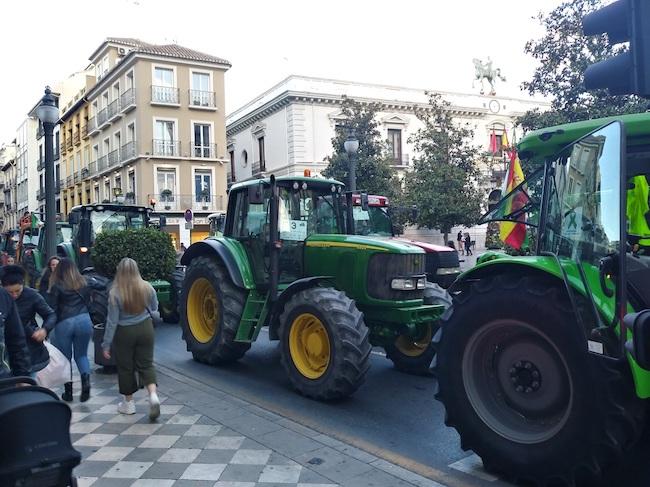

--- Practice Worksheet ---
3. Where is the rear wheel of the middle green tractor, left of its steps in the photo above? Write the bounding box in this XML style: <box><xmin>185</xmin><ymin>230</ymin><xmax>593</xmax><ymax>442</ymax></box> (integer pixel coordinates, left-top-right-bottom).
<box><xmin>180</xmin><ymin>256</ymin><xmax>251</xmax><ymax>365</ymax></box>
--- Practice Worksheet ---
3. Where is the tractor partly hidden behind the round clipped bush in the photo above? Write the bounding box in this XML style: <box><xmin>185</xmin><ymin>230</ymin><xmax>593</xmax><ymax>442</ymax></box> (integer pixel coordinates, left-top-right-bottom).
<box><xmin>66</xmin><ymin>203</ymin><xmax>178</xmax><ymax>323</ymax></box>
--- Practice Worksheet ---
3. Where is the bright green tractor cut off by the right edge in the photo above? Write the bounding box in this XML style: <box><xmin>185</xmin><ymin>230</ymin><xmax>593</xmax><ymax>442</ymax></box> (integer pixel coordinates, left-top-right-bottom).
<box><xmin>432</xmin><ymin>113</ymin><xmax>650</xmax><ymax>486</ymax></box>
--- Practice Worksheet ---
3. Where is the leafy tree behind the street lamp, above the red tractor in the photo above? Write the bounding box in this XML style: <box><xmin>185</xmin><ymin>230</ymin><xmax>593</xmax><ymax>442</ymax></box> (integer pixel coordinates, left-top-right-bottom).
<box><xmin>323</xmin><ymin>96</ymin><xmax>400</xmax><ymax>197</ymax></box>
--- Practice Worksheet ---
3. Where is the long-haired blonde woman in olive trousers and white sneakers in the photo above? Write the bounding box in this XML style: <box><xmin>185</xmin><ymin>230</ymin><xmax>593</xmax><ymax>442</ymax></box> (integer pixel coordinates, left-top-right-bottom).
<box><xmin>102</xmin><ymin>257</ymin><xmax>160</xmax><ymax>419</ymax></box>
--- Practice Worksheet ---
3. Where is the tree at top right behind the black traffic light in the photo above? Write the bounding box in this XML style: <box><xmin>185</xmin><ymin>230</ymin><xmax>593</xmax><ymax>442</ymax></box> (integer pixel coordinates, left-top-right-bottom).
<box><xmin>518</xmin><ymin>0</ymin><xmax>647</xmax><ymax>131</ymax></box>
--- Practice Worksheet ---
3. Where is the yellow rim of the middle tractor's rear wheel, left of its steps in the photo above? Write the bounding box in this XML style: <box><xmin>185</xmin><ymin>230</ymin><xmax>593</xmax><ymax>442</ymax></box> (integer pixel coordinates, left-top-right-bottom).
<box><xmin>187</xmin><ymin>277</ymin><xmax>219</xmax><ymax>343</ymax></box>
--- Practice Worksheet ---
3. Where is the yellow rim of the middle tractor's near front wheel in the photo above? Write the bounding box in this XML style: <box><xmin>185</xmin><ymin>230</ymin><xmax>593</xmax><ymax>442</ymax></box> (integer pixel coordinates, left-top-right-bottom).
<box><xmin>289</xmin><ymin>313</ymin><xmax>330</xmax><ymax>379</ymax></box>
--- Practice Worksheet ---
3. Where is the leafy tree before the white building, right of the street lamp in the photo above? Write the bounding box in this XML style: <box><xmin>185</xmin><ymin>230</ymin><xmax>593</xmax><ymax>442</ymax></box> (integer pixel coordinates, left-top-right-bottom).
<box><xmin>405</xmin><ymin>93</ymin><xmax>483</xmax><ymax>243</ymax></box>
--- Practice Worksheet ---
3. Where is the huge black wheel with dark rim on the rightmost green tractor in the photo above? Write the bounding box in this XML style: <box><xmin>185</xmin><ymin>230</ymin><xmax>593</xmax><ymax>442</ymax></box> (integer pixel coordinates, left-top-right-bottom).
<box><xmin>434</xmin><ymin>275</ymin><xmax>645</xmax><ymax>487</ymax></box>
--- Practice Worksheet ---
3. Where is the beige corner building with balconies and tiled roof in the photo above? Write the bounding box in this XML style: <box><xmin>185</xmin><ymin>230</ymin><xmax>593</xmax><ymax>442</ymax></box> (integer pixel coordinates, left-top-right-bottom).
<box><xmin>61</xmin><ymin>38</ymin><xmax>230</xmax><ymax>245</ymax></box>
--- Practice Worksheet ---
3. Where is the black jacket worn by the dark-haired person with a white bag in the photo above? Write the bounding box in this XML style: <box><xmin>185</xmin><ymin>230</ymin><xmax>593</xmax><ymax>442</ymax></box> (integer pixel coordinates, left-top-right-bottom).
<box><xmin>16</xmin><ymin>287</ymin><xmax>56</xmax><ymax>372</ymax></box>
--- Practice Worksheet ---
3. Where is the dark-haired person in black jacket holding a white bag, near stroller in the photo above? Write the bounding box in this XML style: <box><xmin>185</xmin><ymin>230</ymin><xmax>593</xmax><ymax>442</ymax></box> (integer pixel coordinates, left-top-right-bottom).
<box><xmin>1</xmin><ymin>265</ymin><xmax>56</xmax><ymax>378</ymax></box>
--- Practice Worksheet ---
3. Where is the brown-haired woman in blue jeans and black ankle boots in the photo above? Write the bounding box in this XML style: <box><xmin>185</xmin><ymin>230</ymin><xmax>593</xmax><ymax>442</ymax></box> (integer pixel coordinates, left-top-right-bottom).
<box><xmin>45</xmin><ymin>258</ymin><xmax>93</xmax><ymax>402</ymax></box>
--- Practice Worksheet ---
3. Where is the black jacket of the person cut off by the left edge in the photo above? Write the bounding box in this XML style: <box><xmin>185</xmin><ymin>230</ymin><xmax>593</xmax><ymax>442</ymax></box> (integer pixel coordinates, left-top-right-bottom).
<box><xmin>0</xmin><ymin>288</ymin><xmax>31</xmax><ymax>377</ymax></box>
